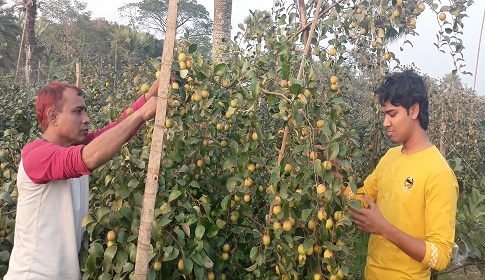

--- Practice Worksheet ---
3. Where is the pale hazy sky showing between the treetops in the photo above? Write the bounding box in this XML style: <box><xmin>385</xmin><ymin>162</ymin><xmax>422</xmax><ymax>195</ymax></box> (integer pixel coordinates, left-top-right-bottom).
<box><xmin>72</xmin><ymin>0</ymin><xmax>485</xmax><ymax>95</ymax></box>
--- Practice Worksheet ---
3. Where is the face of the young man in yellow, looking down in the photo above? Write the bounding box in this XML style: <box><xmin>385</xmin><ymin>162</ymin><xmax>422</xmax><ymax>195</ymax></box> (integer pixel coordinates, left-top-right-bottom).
<box><xmin>381</xmin><ymin>101</ymin><xmax>417</xmax><ymax>144</ymax></box>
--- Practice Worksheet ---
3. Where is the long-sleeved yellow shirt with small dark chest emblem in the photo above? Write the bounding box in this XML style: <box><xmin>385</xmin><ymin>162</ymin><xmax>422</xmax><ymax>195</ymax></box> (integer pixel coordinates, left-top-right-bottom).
<box><xmin>344</xmin><ymin>146</ymin><xmax>458</xmax><ymax>280</ymax></box>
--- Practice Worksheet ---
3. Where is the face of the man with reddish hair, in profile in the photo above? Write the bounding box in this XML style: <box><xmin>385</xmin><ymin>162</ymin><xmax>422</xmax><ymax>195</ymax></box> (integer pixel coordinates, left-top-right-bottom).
<box><xmin>55</xmin><ymin>88</ymin><xmax>89</xmax><ymax>147</ymax></box>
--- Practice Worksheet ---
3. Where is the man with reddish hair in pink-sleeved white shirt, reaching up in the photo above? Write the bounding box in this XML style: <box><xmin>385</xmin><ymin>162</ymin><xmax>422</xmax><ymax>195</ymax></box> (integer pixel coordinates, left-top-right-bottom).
<box><xmin>4</xmin><ymin>80</ymin><xmax>158</xmax><ymax>280</ymax></box>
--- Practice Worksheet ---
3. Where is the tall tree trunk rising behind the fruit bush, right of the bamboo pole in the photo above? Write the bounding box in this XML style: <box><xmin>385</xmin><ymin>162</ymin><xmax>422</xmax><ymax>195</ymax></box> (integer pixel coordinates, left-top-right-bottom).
<box><xmin>212</xmin><ymin>0</ymin><xmax>232</xmax><ymax>64</ymax></box>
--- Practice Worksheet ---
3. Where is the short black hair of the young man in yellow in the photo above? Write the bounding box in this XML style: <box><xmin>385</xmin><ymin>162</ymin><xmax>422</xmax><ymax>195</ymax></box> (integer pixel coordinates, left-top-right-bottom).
<box><xmin>375</xmin><ymin>70</ymin><xmax>429</xmax><ymax>130</ymax></box>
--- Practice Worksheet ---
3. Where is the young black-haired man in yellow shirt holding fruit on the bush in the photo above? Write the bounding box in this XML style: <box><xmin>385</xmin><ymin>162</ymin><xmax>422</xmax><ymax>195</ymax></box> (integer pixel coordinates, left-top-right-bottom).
<box><xmin>344</xmin><ymin>70</ymin><xmax>458</xmax><ymax>280</ymax></box>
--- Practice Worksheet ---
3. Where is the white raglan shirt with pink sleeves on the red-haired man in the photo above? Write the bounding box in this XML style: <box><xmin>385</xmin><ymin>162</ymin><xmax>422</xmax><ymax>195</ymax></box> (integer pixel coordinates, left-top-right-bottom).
<box><xmin>4</xmin><ymin>97</ymin><xmax>145</xmax><ymax>280</ymax></box>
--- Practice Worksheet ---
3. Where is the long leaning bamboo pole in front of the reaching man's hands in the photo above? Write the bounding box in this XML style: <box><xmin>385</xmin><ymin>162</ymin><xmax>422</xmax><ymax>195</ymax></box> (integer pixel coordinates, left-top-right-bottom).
<box><xmin>135</xmin><ymin>0</ymin><xmax>179</xmax><ymax>280</ymax></box>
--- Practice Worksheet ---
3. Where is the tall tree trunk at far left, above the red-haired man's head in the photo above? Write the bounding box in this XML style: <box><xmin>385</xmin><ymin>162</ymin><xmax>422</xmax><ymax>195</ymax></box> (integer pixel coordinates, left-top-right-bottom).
<box><xmin>25</xmin><ymin>0</ymin><xmax>37</xmax><ymax>86</ymax></box>
